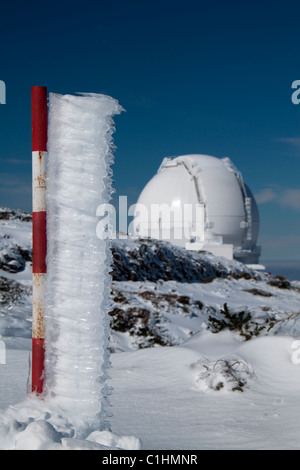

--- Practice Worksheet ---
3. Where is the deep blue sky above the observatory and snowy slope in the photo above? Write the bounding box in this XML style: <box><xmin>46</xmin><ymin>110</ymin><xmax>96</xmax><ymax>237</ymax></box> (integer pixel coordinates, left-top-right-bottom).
<box><xmin>0</xmin><ymin>0</ymin><xmax>300</xmax><ymax>260</ymax></box>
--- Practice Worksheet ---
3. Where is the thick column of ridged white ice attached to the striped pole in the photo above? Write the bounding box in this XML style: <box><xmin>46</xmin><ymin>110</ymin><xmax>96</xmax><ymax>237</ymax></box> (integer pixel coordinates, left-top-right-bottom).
<box><xmin>45</xmin><ymin>93</ymin><xmax>122</xmax><ymax>435</ymax></box>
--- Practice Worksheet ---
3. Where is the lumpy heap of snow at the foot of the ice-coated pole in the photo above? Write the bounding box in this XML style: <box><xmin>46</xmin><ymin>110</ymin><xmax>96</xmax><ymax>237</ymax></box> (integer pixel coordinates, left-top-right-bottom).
<box><xmin>0</xmin><ymin>394</ymin><xmax>141</xmax><ymax>450</ymax></box>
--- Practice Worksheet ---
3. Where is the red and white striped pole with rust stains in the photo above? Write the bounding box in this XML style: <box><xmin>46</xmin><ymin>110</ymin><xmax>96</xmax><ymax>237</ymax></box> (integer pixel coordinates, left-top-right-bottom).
<box><xmin>31</xmin><ymin>86</ymin><xmax>47</xmax><ymax>394</ymax></box>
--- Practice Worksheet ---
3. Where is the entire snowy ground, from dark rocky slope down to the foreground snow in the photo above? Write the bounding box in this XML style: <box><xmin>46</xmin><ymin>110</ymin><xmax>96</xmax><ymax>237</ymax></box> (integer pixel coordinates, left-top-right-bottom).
<box><xmin>0</xmin><ymin>210</ymin><xmax>300</xmax><ymax>450</ymax></box>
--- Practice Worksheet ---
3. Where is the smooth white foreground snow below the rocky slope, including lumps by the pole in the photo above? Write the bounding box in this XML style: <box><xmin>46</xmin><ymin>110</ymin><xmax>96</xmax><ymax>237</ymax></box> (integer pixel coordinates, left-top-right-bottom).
<box><xmin>0</xmin><ymin>332</ymin><xmax>300</xmax><ymax>450</ymax></box>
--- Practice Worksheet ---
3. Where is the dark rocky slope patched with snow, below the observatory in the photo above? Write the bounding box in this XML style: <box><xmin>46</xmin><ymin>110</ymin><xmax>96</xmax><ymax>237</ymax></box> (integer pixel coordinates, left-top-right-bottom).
<box><xmin>0</xmin><ymin>208</ymin><xmax>300</xmax><ymax>352</ymax></box>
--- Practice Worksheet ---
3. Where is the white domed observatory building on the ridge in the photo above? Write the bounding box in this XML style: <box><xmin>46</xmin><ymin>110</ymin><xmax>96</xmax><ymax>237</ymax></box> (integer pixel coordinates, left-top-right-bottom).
<box><xmin>133</xmin><ymin>155</ymin><xmax>260</xmax><ymax>264</ymax></box>
